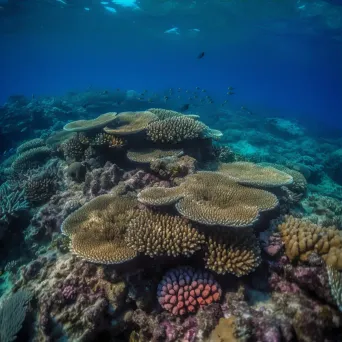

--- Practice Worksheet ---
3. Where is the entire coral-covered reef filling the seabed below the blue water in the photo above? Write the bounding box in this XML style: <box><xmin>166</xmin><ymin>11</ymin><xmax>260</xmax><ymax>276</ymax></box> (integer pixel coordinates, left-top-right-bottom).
<box><xmin>0</xmin><ymin>94</ymin><xmax>342</xmax><ymax>342</ymax></box>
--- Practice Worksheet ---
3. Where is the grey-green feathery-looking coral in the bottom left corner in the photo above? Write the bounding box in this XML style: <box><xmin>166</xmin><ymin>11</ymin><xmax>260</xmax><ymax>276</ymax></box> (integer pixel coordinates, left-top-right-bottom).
<box><xmin>0</xmin><ymin>290</ymin><xmax>31</xmax><ymax>342</ymax></box>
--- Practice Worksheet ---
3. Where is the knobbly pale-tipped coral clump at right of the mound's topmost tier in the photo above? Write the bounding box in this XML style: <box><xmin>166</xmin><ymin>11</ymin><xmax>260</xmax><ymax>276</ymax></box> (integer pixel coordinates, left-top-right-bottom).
<box><xmin>147</xmin><ymin>116</ymin><xmax>206</xmax><ymax>144</ymax></box>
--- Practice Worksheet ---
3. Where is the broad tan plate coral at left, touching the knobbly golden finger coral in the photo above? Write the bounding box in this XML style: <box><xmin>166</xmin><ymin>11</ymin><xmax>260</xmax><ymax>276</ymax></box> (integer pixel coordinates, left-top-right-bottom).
<box><xmin>61</xmin><ymin>195</ymin><xmax>137</xmax><ymax>264</ymax></box>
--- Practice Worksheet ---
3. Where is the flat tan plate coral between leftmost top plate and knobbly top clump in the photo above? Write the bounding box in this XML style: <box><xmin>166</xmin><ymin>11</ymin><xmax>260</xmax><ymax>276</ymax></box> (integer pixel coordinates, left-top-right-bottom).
<box><xmin>104</xmin><ymin>111</ymin><xmax>158</xmax><ymax>135</ymax></box>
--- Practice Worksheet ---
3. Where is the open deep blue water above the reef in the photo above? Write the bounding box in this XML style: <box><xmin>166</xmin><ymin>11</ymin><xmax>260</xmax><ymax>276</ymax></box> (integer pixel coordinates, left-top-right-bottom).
<box><xmin>0</xmin><ymin>0</ymin><xmax>342</xmax><ymax>129</ymax></box>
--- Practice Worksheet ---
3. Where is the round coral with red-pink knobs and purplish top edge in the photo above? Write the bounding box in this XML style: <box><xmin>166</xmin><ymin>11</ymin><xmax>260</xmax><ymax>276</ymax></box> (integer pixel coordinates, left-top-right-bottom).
<box><xmin>157</xmin><ymin>267</ymin><xmax>222</xmax><ymax>316</ymax></box>
